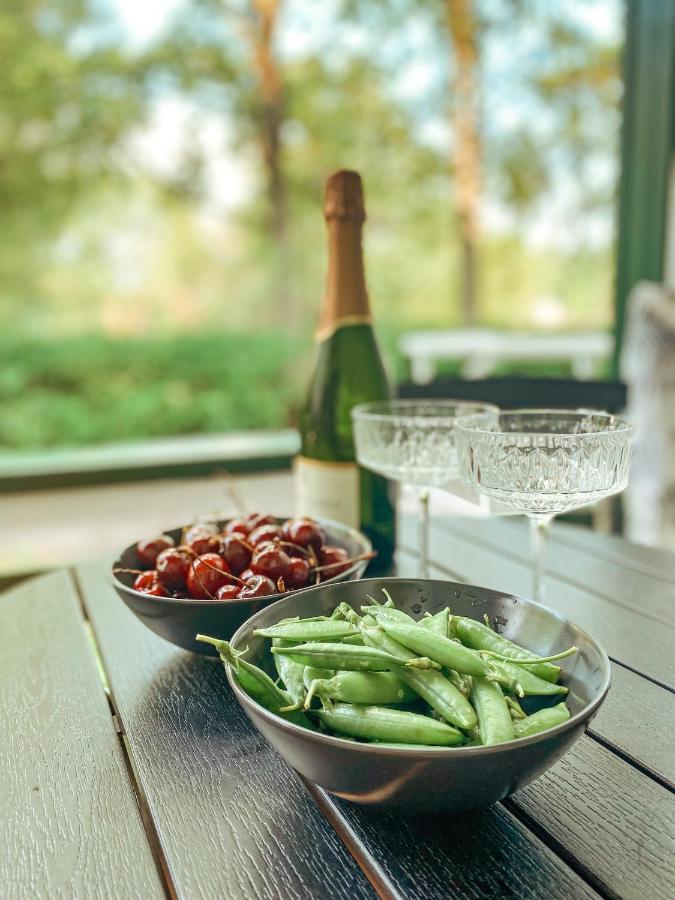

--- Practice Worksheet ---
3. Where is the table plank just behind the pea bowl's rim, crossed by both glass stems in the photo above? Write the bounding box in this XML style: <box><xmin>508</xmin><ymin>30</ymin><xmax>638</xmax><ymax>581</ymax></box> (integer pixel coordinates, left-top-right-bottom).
<box><xmin>399</xmin><ymin>517</ymin><xmax>675</xmax><ymax>686</ymax></box>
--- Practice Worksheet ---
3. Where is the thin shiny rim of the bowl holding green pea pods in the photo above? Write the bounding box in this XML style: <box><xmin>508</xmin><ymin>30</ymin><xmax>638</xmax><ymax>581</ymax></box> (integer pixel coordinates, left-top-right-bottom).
<box><xmin>223</xmin><ymin>576</ymin><xmax>612</xmax><ymax>759</ymax></box>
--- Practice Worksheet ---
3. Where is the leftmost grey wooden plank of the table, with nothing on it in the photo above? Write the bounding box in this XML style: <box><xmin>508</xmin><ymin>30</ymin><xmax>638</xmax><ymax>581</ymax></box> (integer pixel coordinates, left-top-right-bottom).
<box><xmin>0</xmin><ymin>572</ymin><xmax>164</xmax><ymax>900</ymax></box>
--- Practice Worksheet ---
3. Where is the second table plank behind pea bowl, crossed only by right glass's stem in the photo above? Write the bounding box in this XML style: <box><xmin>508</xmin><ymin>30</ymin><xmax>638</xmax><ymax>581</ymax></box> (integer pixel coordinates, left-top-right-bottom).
<box><xmin>434</xmin><ymin>516</ymin><xmax>675</xmax><ymax>626</ymax></box>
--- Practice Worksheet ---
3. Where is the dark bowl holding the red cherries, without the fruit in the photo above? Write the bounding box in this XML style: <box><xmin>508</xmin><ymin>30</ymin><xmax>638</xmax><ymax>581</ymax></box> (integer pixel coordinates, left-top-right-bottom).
<box><xmin>113</xmin><ymin>519</ymin><xmax>372</xmax><ymax>657</ymax></box>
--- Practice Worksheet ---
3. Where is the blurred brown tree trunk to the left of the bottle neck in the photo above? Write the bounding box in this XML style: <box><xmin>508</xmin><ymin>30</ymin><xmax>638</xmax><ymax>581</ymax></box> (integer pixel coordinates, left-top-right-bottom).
<box><xmin>249</xmin><ymin>0</ymin><xmax>295</xmax><ymax>325</ymax></box>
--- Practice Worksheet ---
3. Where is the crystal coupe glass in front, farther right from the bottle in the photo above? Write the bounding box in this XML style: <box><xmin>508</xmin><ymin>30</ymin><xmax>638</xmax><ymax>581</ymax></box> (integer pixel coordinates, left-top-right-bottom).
<box><xmin>455</xmin><ymin>409</ymin><xmax>634</xmax><ymax>602</ymax></box>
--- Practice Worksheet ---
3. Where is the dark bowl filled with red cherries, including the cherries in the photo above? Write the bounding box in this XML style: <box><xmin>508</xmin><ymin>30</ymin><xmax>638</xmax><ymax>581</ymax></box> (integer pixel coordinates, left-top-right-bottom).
<box><xmin>112</xmin><ymin>513</ymin><xmax>374</xmax><ymax>656</ymax></box>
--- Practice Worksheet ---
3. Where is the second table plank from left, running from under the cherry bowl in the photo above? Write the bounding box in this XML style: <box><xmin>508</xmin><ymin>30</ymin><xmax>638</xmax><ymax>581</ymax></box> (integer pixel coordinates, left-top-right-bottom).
<box><xmin>78</xmin><ymin>566</ymin><xmax>373</xmax><ymax>900</ymax></box>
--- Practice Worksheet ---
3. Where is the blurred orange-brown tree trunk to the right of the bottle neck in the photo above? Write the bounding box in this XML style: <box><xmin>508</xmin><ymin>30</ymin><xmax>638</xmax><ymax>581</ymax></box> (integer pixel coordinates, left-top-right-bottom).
<box><xmin>446</xmin><ymin>0</ymin><xmax>481</xmax><ymax>325</ymax></box>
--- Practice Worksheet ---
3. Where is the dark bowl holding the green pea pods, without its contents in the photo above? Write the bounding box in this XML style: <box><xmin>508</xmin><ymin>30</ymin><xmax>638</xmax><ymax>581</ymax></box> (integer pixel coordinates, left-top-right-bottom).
<box><xmin>227</xmin><ymin>578</ymin><xmax>610</xmax><ymax>811</ymax></box>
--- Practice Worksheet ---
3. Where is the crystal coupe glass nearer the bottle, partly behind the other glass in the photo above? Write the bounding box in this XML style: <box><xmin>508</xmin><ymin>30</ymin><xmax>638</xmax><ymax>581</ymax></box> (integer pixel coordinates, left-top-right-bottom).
<box><xmin>352</xmin><ymin>400</ymin><xmax>498</xmax><ymax>578</ymax></box>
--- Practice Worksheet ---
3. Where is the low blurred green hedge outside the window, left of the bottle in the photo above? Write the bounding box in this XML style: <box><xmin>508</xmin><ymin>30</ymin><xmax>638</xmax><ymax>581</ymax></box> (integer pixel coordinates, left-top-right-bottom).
<box><xmin>0</xmin><ymin>333</ymin><xmax>301</xmax><ymax>450</ymax></box>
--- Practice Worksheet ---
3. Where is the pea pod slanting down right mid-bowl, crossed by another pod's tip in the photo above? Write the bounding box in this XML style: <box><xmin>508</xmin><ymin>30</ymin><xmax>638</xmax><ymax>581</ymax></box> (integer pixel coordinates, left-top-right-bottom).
<box><xmin>361</xmin><ymin>626</ymin><xmax>477</xmax><ymax>730</ymax></box>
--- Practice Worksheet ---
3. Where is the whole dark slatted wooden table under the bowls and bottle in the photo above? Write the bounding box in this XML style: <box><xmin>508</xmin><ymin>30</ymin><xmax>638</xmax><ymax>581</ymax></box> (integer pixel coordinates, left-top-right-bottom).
<box><xmin>0</xmin><ymin>476</ymin><xmax>675</xmax><ymax>900</ymax></box>
